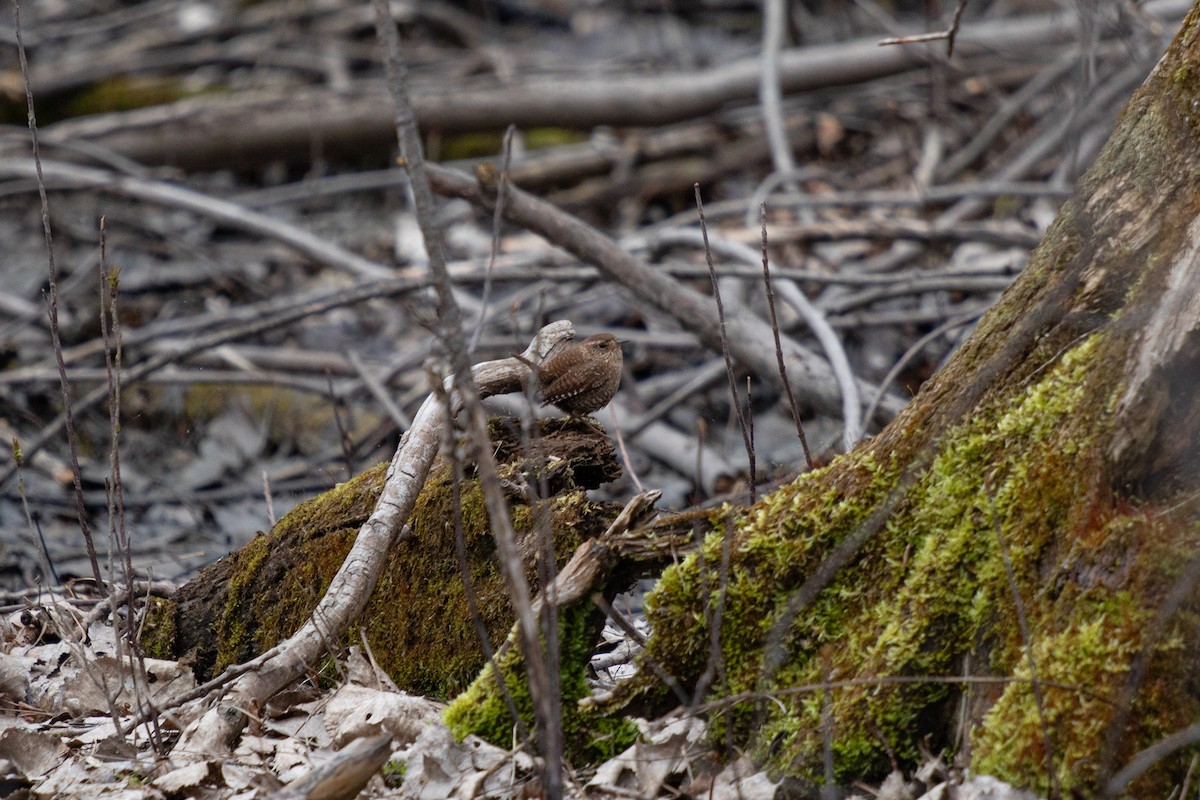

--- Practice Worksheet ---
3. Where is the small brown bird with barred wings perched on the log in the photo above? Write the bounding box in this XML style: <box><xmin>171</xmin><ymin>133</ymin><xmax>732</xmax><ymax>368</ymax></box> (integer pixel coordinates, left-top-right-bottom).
<box><xmin>538</xmin><ymin>333</ymin><xmax>623</xmax><ymax>416</ymax></box>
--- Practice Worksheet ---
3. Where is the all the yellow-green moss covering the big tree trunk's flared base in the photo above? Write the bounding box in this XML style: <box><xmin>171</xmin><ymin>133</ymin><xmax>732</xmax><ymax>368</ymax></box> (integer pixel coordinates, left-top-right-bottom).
<box><xmin>633</xmin><ymin>335</ymin><xmax>1195</xmax><ymax>790</ymax></box>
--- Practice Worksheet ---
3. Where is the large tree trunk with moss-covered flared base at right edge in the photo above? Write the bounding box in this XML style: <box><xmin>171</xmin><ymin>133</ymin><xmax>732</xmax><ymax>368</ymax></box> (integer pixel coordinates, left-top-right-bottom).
<box><xmin>630</xmin><ymin>8</ymin><xmax>1200</xmax><ymax>796</ymax></box>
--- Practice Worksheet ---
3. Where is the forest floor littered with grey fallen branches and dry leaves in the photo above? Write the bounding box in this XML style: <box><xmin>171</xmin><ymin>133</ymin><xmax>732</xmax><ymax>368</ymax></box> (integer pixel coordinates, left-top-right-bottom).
<box><xmin>0</xmin><ymin>0</ymin><xmax>1188</xmax><ymax>798</ymax></box>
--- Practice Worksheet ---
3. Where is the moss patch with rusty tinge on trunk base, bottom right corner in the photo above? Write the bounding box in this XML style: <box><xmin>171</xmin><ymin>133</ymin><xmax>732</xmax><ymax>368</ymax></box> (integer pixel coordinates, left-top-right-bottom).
<box><xmin>972</xmin><ymin>509</ymin><xmax>1200</xmax><ymax>796</ymax></box>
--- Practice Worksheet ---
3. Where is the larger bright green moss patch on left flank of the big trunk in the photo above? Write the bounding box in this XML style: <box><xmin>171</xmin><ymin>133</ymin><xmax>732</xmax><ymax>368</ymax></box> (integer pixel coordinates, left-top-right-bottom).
<box><xmin>647</xmin><ymin>337</ymin><xmax>1161</xmax><ymax>777</ymax></box>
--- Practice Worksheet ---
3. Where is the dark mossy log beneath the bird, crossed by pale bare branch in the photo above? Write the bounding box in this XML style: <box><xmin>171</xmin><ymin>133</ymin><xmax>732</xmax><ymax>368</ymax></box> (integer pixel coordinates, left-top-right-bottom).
<box><xmin>144</xmin><ymin>419</ymin><xmax>620</xmax><ymax>697</ymax></box>
